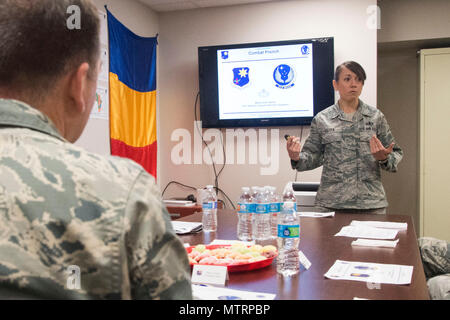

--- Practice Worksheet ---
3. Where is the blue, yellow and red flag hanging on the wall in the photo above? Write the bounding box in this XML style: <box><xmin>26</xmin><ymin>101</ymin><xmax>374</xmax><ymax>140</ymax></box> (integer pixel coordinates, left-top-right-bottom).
<box><xmin>107</xmin><ymin>10</ymin><xmax>158</xmax><ymax>178</ymax></box>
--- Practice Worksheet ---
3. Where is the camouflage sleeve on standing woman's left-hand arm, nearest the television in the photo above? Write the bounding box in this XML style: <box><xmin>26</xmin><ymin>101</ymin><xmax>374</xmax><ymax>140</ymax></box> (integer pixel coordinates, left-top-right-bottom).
<box><xmin>291</xmin><ymin>118</ymin><xmax>323</xmax><ymax>171</ymax></box>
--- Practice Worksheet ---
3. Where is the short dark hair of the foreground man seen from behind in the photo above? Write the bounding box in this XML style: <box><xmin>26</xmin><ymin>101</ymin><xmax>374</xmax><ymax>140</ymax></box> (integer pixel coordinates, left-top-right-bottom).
<box><xmin>0</xmin><ymin>0</ymin><xmax>100</xmax><ymax>92</ymax></box>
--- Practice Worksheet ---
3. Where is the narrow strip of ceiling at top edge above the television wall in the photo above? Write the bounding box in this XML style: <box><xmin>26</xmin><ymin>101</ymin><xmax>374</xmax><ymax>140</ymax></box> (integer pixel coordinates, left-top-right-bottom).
<box><xmin>139</xmin><ymin>0</ymin><xmax>292</xmax><ymax>12</ymax></box>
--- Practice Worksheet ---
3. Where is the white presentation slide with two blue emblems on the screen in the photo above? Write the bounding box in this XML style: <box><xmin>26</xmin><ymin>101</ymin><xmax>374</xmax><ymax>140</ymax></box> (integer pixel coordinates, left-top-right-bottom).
<box><xmin>217</xmin><ymin>43</ymin><xmax>313</xmax><ymax>120</ymax></box>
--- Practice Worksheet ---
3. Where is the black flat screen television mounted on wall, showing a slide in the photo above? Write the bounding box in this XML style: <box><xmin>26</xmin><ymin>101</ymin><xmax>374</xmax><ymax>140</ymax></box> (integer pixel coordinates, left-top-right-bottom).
<box><xmin>198</xmin><ymin>37</ymin><xmax>334</xmax><ymax>128</ymax></box>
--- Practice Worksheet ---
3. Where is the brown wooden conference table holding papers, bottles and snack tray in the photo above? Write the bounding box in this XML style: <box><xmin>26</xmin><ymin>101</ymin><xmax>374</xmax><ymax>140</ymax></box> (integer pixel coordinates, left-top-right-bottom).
<box><xmin>179</xmin><ymin>209</ymin><xmax>429</xmax><ymax>300</ymax></box>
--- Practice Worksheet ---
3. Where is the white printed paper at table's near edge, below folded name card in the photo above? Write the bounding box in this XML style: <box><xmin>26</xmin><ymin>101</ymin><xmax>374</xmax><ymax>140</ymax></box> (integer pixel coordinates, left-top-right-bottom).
<box><xmin>192</xmin><ymin>284</ymin><xmax>276</xmax><ymax>300</ymax></box>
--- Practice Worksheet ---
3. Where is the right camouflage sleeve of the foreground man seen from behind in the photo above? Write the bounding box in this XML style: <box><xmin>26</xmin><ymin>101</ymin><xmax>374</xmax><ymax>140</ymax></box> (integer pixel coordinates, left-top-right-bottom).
<box><xmin>125</xmin><ymin>172</ymin><xmax>192</xmax><ymax>299</ymax></box>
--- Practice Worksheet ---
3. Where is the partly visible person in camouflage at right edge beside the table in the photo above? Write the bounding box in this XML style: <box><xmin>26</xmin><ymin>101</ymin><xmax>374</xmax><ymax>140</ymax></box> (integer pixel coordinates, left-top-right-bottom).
<box><xmin>419</xmin><ymin>237</ymin><xmax>450</xmax><ymax>300</ymax></box>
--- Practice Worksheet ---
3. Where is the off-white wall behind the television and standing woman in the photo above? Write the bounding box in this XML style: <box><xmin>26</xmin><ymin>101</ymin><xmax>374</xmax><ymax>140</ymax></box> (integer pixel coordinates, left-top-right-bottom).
<box><xmin>158</xmin><ymin>0</ymin><xmax>377</xmax><ymax>205</ymax></box>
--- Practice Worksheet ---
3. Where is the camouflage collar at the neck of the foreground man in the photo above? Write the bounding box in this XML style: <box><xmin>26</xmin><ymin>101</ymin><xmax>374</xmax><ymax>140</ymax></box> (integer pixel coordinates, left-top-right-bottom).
<box><xmin>0</xmin><ymin>99</ymin><xmax>66</xmax><ymax>141</ymax></box>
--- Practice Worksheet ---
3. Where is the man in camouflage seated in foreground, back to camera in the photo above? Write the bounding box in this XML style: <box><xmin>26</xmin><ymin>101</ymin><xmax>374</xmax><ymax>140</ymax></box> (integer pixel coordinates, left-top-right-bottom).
<box><xmin>0</xmin><ymin>0</ymin><xmax>192</xmax><ymax>299</ymax></box>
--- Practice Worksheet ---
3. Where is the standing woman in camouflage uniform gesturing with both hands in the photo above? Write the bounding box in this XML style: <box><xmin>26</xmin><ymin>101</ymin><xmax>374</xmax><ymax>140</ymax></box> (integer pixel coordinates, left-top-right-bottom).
<box><xmin>287</xmin><ymin>62</ymin><xmax>403</xmax><ymax>213</ymax></box>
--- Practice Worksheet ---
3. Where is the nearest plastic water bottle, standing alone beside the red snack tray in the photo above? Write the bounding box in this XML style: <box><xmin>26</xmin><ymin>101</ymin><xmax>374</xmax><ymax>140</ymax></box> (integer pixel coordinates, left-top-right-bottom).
<box><xmin>277</xmin><ymin>201</ymin><xmax>300</xmax><ymax>276</ymax></box>
